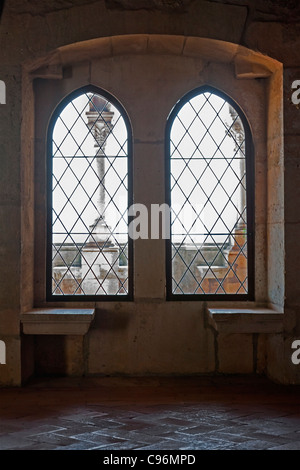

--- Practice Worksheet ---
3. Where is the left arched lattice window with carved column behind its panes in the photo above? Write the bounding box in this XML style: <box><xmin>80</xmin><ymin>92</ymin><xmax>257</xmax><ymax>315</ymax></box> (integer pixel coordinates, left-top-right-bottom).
<box><xmin>47</xmin><ymin>86</ymin><xmax>132</xmax><ymax>300</ymax></box>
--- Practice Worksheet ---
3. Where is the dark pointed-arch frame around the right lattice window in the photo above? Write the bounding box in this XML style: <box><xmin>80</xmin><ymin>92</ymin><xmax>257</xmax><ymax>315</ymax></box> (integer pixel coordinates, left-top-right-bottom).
<box><xmin>165</xmin><ymin>85</ymin><xmax>255</xmax><ymax>302</ymax></box>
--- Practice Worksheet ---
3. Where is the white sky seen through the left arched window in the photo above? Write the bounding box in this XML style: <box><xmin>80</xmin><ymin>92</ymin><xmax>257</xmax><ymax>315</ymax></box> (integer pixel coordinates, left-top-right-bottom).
<box><xmin>53</xmin><ymin>95</ymin><xmax>127</xmax><ymax>242</ymax></box>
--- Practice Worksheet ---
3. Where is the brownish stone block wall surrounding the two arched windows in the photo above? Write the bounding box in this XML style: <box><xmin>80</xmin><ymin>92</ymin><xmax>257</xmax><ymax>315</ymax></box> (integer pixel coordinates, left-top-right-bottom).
<box><xmin>0</xmin><ymin>0</ymin><xmax>300</xmax><ymax>385</ymax></box>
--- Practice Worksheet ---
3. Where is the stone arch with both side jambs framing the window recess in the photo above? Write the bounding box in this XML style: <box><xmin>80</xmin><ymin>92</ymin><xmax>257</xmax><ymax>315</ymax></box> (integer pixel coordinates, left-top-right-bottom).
<box><xmin>22</xmin><ymin>34</ymin><xmax>284</xmax><ymax>310</ymax></box>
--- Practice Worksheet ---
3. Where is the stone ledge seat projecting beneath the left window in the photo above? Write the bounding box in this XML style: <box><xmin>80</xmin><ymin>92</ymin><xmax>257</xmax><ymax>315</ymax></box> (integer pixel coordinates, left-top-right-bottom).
<box><xmin>21</xmin><ymin>308</ymin><xmax>95</xmax><ymax>335</ymax></box>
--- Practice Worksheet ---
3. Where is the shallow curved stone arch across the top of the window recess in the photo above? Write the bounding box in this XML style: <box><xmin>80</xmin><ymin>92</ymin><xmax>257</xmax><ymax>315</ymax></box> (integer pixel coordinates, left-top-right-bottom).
<box><xmin>24</xmin><ymin>34</ymin><xmax>282</xmax><ymax>79</ymax></box>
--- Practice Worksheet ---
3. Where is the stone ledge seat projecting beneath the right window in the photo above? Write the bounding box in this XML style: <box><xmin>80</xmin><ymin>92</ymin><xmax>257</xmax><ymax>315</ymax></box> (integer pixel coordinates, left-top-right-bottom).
<box><xmin>207</xmin><ymin>308</ymin><xmax>283</xmax><ymax>334</ymax></box>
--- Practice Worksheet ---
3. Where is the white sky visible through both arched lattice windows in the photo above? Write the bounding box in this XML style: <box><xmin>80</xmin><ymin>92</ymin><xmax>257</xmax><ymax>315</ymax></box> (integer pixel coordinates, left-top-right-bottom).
<box><xmin>53</xmin><ymin>90</ymin><xmax>245</xmax><ymax>248</ymax></box>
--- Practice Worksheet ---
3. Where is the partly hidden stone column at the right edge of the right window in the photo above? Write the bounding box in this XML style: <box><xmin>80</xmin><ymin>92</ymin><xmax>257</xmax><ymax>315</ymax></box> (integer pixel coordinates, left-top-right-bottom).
<box><xmin>225</xmin><ymin>106</ymin><xmax>247</xmax><ymax>293</ymax></box>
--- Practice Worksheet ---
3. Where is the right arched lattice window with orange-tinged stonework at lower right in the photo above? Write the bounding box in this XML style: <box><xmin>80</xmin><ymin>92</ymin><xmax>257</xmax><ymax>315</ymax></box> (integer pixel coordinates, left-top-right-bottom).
<box><xmin>166</xmin><ymin>87</ymin><xmax>254</xmax><ymax>300</ymax></box>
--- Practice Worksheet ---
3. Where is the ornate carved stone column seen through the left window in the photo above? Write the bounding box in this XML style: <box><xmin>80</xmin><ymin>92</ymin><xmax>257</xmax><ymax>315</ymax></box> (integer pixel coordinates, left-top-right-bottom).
<box><xmin>82</xmin><ymin>95</ymin><xmax>119</xmax><ymax>295</ymax></box>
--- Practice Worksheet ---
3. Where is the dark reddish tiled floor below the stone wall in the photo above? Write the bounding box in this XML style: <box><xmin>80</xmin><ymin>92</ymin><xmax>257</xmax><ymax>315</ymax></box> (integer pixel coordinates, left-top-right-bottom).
<box><xmin>0</xmin><ymin>377</ymin><xmax>300</xmax><ymax>451</ymax></box>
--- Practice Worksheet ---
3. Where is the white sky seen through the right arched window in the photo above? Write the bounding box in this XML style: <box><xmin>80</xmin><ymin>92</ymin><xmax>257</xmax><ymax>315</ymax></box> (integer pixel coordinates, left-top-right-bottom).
<box><xmin>171</xmin><ymin>94</ymin><xmax>245</xmax><ymax>243</ymax></box>
